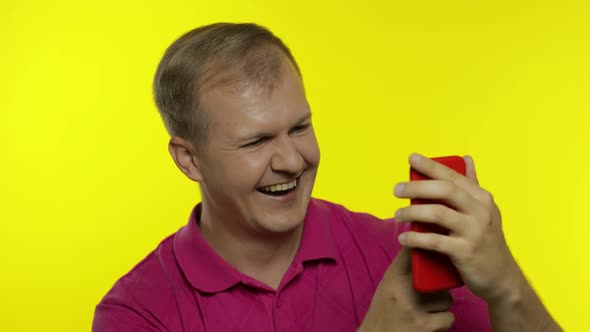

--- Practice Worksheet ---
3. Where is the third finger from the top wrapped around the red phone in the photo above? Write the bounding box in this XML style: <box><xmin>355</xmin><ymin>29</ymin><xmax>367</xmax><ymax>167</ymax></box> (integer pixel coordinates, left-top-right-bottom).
<box><xmin>395</xmin><ymin>204</ymin><xmax>468</xmax><ymax>235</ymax></box>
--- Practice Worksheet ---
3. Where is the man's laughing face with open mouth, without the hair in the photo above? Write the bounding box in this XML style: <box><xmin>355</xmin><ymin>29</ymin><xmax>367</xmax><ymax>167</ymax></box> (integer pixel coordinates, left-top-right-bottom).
<box><xmin>198</xmin><ymin>59</ymin><xmax>320</xmax><ymax>233</ymax></box>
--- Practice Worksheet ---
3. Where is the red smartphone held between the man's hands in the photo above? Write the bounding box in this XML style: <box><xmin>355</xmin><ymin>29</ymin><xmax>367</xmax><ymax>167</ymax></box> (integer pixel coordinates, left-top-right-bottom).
<box><xmin>410</xmin><ymin>156</ymin><xmax>465</xmax><ymax>292</ymax></box>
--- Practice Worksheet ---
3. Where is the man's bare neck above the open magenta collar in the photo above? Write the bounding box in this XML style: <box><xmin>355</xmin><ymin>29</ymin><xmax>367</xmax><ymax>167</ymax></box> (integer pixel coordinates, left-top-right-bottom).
<box><xmin>199</xmin><ymin>207</ymin><xmax>303</xmax><ymax>289</ymax></box>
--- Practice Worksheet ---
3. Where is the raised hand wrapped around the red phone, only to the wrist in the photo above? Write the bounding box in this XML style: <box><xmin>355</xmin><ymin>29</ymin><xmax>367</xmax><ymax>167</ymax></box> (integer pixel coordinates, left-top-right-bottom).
<box><xmin>394</xmin><ymin>154</ymin><xmax>521</xmax><ymax>302</ymax></box>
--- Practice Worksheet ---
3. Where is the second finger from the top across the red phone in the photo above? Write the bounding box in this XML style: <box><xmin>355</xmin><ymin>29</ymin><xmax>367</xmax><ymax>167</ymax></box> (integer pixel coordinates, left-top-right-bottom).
<box><xmin>394</xmin><ymin>180</ymin><xmax>480</xmax><ymax>212</ymax></box>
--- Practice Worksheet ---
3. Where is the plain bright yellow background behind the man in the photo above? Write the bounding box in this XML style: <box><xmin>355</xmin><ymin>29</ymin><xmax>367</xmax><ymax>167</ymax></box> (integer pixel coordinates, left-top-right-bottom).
<box><xmin>0</xmin><ymin>0</ymin><xmax>590</xmax><ymax>331</ymax></box>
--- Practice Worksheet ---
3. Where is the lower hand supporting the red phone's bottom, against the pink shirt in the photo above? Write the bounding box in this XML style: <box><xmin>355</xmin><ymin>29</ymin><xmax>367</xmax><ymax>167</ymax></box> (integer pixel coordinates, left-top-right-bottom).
<box><xmin>358</xmin><ymin>248</ymin><xmax>454</xmax><ymax>332</ymax></box>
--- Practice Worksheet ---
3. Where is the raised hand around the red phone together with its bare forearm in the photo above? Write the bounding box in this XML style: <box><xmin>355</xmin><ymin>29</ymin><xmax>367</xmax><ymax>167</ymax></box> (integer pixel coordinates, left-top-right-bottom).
<box><xmin>394</xmin><ymin>154</ymin><xmax>562</xmax><ymax>332</ymax></box>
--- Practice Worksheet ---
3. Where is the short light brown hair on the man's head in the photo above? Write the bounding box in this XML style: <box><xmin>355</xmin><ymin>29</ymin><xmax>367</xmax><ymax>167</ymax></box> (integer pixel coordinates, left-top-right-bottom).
<box><xmin>154</xmin><ymin>23</ymin><xmax>301</xmax><ymax>147</ymax></box>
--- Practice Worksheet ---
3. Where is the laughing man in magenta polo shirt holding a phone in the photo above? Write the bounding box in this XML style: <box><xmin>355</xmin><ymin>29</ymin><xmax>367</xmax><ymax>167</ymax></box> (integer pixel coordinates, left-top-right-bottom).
<box><xmin>93</xmin><ymin>24</ymin><xmax>560</xmax><ymax>332</ymax></box>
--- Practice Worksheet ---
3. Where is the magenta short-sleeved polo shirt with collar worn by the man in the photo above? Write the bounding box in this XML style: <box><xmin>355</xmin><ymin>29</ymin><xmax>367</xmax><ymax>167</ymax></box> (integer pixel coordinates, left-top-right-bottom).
<box><xmin>92</xmin><ymin>199</ymin><xmax>491</xmax><ymax>332</ymax></box>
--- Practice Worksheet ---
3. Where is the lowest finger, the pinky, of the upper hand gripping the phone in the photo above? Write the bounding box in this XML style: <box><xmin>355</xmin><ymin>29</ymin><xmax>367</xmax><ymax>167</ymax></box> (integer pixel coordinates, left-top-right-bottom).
<box><xmin>398</xmin><ymin>231</ymin><xmax>466</xmax><ymax>257</ymax></box>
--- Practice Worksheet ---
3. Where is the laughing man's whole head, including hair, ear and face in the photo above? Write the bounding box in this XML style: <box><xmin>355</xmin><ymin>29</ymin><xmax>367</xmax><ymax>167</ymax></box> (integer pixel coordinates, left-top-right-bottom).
<box><xmin>154</xmin><ymin>23</ymin><xmax>319</xmax><ymax>233</ymax></box>
